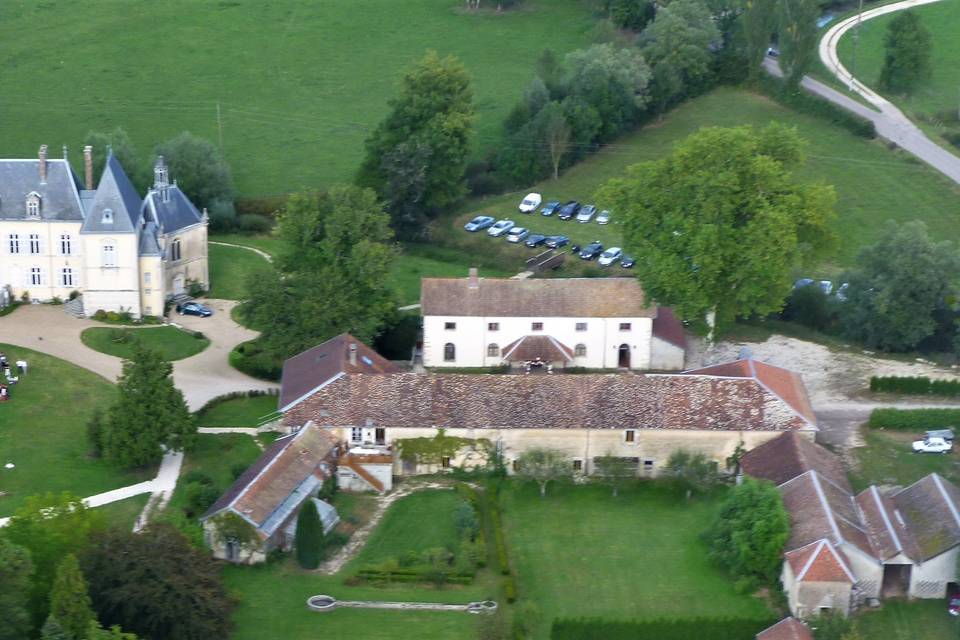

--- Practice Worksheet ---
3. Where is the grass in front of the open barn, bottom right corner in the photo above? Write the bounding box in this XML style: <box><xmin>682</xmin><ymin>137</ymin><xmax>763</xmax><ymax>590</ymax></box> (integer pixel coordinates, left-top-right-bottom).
<box><xmin>857</xmin><ymin>598</ymin><xmax>960</xmax><ymax>640</ymax></box>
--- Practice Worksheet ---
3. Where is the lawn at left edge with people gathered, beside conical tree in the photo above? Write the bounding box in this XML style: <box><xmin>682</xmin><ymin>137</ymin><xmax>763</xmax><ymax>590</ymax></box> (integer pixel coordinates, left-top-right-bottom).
<box><xmin>0</xmin><ymin>344</ymin><xmax>156</xmax><ymax>517</ymax></box>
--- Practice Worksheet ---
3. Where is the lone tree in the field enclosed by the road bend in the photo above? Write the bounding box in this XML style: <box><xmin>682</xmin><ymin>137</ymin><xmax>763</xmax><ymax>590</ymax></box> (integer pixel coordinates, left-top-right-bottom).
<box><xmin>880</xmin><ymin>11</ymin><xmax>932</xmax><ymax>93</ymax></box>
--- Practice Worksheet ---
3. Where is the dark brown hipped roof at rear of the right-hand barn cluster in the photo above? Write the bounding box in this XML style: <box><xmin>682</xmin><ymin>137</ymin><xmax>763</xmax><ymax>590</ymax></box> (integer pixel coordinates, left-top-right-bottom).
<box><xmin>741</xmin><ymin>431</ymin><xmax>852</xmax><ymax>491</ymax></box>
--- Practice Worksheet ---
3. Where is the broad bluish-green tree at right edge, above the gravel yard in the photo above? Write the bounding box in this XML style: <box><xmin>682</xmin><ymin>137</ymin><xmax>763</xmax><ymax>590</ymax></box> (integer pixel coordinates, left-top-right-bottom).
<box><xmin>842</xmin><ymin>220</ymin><xmax>960</xmax><ymax>351</ymax></box>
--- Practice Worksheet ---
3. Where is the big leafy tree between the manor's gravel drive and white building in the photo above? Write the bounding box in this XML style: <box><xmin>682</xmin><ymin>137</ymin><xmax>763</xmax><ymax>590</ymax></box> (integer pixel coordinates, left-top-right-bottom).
<box><xmin>246</xmin><ymin>187</ymin><xmax>396</xmax><ymax>359</ymax></box>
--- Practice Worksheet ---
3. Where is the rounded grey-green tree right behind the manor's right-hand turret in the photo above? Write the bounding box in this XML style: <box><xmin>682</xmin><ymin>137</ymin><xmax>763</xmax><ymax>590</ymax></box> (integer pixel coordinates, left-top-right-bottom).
<box><xmin>154</xmin><ymin>131</ymin><xmax>234</xmax><ymax>209</ymax></box>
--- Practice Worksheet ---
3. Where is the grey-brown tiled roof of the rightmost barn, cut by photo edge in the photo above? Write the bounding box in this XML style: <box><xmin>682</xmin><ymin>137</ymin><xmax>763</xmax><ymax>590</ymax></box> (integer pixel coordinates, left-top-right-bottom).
<box><xmin>891</xmin><ymin>473</ymin><xmax>960</xmax><ymax>561</ymax></box>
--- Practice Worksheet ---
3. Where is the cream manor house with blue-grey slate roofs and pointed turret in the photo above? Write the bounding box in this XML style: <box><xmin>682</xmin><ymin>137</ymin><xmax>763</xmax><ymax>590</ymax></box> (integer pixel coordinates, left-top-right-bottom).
<box><xmin>0</xmin><ymin>145</ymin><xmax>209</xmax><ymax>317</ymax></box>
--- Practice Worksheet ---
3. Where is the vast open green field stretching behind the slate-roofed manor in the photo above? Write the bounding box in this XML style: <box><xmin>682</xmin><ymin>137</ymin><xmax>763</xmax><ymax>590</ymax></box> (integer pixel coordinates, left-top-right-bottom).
<box><xmin>0</xmin><ymin>0</ymin><xmax>594</xmax><ymax>196</ymax></box>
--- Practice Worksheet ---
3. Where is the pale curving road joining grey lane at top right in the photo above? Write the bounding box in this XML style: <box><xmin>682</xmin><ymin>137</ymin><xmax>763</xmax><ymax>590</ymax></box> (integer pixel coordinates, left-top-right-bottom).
<box><xmin>812</xmin><ymin>0</ymin><xmax>960</xmax><ymax>183</ymax></box>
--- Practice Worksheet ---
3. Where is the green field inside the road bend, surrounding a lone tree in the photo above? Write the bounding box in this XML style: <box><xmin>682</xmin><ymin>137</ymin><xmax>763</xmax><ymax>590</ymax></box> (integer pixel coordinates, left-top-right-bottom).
<box><xmin>837</xmin><ymin>2</ymin><xmax>960</xmax><ymax>119</ymax></box>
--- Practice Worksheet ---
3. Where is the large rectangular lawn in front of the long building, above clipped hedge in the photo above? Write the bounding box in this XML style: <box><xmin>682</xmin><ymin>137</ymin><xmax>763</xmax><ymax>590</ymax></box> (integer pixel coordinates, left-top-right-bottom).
<box><xmin>503</xmin><ymin>483</ymin><xmax>771</xmax><ymax>638</ymax></box>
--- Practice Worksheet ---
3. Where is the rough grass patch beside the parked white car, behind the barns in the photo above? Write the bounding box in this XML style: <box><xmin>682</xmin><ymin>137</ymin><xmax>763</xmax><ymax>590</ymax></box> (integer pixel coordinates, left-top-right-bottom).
<box><xmin>850</xmin><ymin>427</ymin><xmax>960</xmax><ymax>491</ymax></box>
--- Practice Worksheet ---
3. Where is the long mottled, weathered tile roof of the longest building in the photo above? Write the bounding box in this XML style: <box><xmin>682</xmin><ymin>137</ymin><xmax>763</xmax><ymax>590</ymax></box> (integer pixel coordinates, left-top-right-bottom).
<box><xmin>285</xmin><ymin>373</ymin><xmax>809</xmax><ymax>431</ymax></box>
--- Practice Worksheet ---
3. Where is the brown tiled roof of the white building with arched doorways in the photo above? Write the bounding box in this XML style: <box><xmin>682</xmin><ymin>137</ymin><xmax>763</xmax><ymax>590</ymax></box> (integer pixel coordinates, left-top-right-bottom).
<box><xmin>420</xmin><ymin>277</ymin><xmax>657</xmax><ymax>318</ymax></box>
